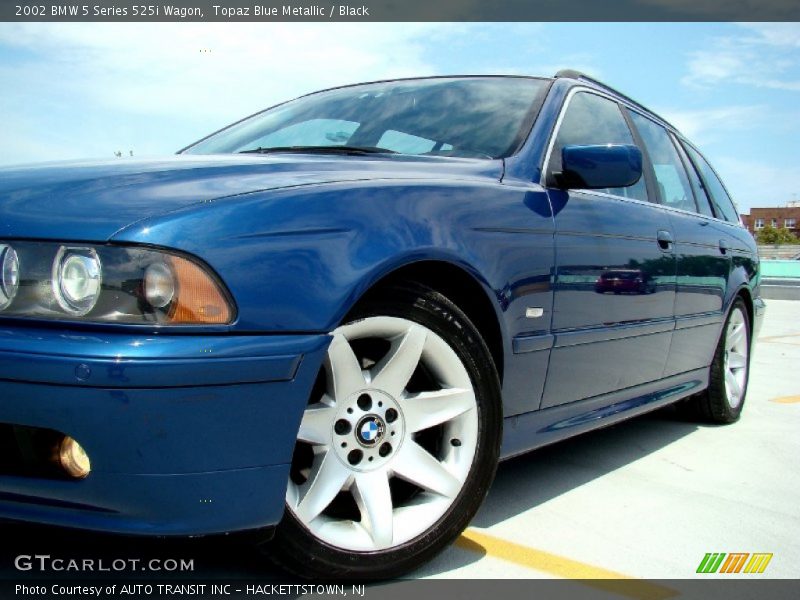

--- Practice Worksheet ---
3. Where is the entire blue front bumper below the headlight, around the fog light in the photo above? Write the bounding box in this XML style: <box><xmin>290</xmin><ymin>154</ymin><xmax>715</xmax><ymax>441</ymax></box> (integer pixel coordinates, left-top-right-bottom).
<box><xmin>0</xmin><ymin>327</ymin><xmax>329</xmax><ymax>535</ymax></box>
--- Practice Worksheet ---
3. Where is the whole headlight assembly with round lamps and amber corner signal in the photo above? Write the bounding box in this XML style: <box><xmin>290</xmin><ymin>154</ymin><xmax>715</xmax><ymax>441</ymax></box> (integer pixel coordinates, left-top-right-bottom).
<box><xmin>0</xmin><ymin>242</ymin><xmax>235</xmax><ymax>325</ymax></box>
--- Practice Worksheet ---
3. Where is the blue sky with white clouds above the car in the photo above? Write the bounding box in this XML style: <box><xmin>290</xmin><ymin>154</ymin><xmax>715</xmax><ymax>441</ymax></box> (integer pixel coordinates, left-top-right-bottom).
<box><xmin>0</xmin><ymin>23</ymin><xmax>800</xmax><ymax>212</ymax></box>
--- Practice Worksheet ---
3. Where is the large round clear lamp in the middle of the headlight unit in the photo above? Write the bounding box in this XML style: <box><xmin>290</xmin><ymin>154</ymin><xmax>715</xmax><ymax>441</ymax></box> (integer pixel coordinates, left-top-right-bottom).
<box><xmin>52</xmin><ymin>246</ymin><xmax>102</xmax><ymax>316</ymax></box>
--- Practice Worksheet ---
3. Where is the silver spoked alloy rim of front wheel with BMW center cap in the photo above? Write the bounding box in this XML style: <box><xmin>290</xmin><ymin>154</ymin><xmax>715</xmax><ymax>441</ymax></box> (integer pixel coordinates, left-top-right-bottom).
<box><xmin>286</xmin><ymin>316</ymin><xmax>478</xmax><ymax>551</ymax></box>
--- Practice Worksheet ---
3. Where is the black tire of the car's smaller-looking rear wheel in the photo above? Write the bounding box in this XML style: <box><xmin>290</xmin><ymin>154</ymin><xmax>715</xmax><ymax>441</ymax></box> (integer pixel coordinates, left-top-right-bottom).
<box><xmin>679</xmin><ymin>297</ymin><xmax>751</xmax><ymax>425</ymax></box>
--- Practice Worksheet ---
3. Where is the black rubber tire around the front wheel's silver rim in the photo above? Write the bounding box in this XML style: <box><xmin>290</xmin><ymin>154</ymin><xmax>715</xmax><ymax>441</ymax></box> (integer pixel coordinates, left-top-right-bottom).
<box><xmin>264</xmin><ymin>284</ymin><xmax>503</xmax><ymax>580</ymax></box>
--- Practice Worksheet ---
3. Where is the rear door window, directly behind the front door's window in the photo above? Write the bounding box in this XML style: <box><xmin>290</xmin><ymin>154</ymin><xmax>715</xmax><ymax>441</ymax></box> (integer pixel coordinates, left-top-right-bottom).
<box><xmin>630</xmin><ymin>112</ymin><xmax>697</xmax><ymax>212</ymax></box>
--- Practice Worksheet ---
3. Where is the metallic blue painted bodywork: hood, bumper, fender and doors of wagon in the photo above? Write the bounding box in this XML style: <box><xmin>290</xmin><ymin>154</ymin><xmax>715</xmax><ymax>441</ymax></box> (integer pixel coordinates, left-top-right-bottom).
<box><xmin>0</xmin><ymin>78</ymin><xmax>763</xmax><ymax>534</ymax></box>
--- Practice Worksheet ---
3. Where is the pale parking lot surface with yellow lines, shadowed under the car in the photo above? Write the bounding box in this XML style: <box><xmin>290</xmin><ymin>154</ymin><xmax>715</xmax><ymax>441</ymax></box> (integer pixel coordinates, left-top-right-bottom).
<box><xmin>0</xmin><ymin>300</ymin><xmax>800</xmax><ymax>580</ymax></box>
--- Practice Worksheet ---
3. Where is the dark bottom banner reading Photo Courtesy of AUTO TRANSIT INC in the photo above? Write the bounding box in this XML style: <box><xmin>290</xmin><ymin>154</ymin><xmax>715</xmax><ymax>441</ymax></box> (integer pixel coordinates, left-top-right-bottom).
<box><xmin>0</xmin><ymin>579</ymin><xmax>800</xmax><ymax>600</ymax></box>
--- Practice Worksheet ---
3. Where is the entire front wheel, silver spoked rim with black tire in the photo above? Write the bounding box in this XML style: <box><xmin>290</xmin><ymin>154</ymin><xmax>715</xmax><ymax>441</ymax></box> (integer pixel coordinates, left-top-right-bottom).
<box><xmin>268</xmin><ymin>282</ymin><xmax>503</xmax><ymax>579</ymax></box>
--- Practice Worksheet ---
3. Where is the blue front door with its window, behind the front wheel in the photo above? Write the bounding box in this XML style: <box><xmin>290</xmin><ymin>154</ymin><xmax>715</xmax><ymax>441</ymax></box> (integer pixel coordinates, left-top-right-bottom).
<box><xmin>541</xmin><ymin>89</ymin><xmax>675</xmax><ymax>408</ymax></box>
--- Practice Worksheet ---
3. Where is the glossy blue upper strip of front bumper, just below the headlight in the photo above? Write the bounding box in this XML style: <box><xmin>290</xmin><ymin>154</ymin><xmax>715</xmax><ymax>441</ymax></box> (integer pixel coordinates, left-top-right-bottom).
<box><xmin>0</xmin><ymin>328</ymin><xmax>328</xmax><ymax>388</ymax></box>
